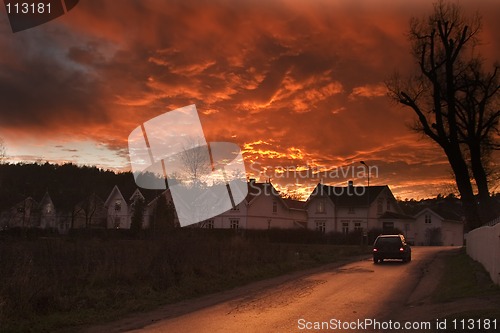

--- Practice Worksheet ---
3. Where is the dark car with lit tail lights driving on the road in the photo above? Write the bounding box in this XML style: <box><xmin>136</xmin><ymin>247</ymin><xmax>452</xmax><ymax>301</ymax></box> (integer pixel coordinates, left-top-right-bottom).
<box><xmin>373</xmin><ymin>235</ymin><xmax>411</xmax><ymax>264</ymax></box>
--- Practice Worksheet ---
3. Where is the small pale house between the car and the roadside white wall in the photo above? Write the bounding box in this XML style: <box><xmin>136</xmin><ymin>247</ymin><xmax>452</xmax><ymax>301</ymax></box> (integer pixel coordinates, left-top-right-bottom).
<box><xmin>413</xmin><ymin>207</ymin><xmax>464</xmax><ymax>246</ymax></box>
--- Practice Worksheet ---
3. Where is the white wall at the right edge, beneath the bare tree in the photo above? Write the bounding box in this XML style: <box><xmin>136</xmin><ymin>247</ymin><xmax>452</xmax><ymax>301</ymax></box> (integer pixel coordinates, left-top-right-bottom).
<box><xmin>466</xmin><ymin>223</ymin><xmax>500</xmax><ymax>285</ymax></box>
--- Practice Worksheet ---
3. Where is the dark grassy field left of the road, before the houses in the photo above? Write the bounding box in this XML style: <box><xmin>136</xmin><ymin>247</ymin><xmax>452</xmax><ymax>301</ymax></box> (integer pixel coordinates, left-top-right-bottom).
<box><xmin>0</xmin><ymin>230</ymin><xmax>369</xmax><ymax>333</ymax></box>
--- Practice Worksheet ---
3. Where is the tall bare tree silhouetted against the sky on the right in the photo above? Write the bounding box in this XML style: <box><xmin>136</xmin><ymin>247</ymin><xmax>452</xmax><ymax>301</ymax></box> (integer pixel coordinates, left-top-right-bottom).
<box><xmin>387</xmin><ymin>1</ymin><xmax>498</xmax><ymax>229</ymax></box>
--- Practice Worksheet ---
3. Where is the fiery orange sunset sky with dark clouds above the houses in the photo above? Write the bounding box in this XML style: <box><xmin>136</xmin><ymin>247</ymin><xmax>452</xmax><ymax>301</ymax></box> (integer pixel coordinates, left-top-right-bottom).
<box><xmin>0</xmin><ymin>0</ymin><xmax>500</xmax><ymax>198</ymax></box>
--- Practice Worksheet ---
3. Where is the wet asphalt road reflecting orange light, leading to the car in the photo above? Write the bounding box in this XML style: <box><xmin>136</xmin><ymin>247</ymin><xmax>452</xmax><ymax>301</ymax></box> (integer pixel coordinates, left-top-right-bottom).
<box><xmin>125</xmin><ymin>247</ymin><xmax>453</xmax><ymax>333</ymax></box>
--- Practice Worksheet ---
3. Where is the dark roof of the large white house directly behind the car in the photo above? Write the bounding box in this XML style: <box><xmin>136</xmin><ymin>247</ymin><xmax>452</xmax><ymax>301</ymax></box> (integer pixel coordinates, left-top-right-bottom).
<box><xmin>311</xmin><ymin>184</ymin><xmax>390</xmax><ymax>206</ymax></box>
